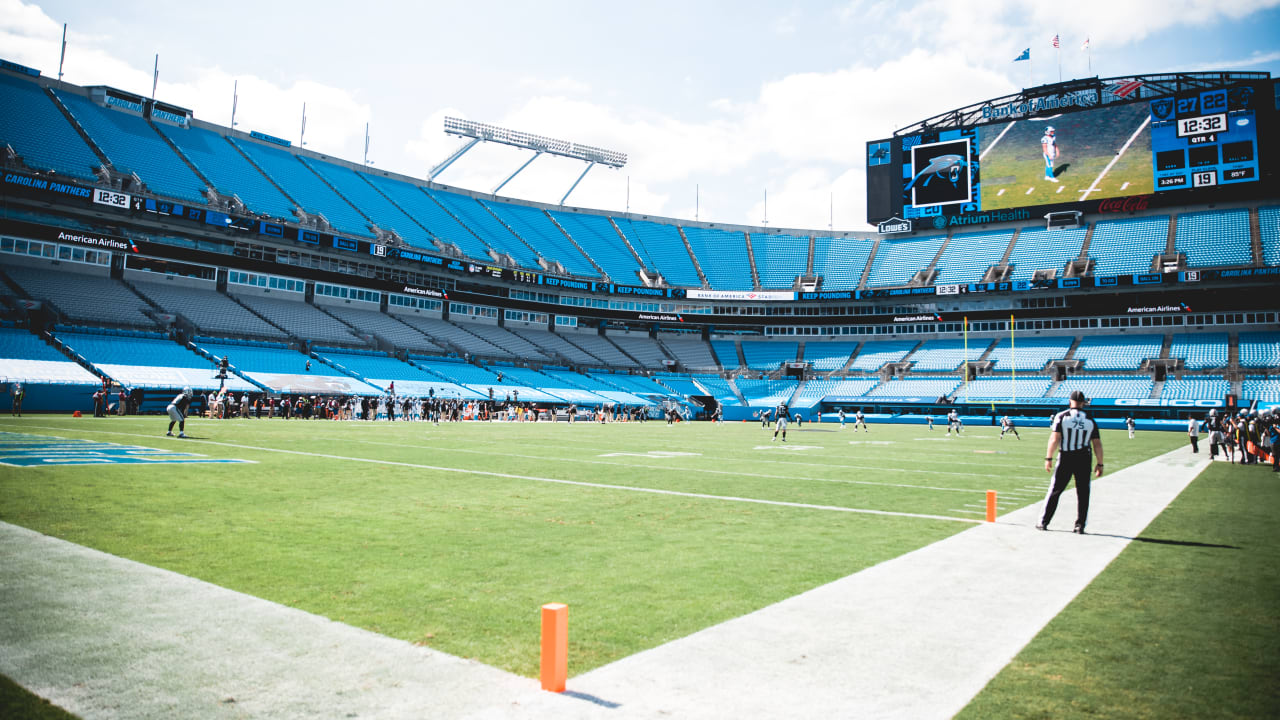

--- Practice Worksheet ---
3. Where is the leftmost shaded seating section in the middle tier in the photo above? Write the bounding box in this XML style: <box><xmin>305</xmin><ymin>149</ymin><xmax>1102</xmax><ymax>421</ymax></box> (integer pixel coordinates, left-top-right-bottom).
<box><xmin>5</xmin><ymin>265</ymin><xmax>155</xmax><ymax>328</ymax></box>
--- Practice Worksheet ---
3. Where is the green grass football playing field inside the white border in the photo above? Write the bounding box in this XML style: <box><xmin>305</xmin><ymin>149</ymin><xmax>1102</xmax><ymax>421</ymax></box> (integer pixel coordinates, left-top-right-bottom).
<box><xmin>0</xmin><ymin>416</ymin><xmax>1276</xmax><ymax>716</ymax></box>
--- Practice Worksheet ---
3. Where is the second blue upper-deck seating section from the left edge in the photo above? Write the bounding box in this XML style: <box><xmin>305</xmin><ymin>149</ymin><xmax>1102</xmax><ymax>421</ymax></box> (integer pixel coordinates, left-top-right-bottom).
<box><xmin>54</xmin><ymin>90</ymin><xmax>205</xmax><ymax>205</ymax></box>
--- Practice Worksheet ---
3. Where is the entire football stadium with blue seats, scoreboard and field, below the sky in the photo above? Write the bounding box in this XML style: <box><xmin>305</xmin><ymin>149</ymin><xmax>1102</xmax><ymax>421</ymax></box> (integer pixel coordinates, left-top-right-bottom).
<box><xmin>0</xmin><ymin>9</ymin><xmax>1280</xmax><ymax>719</ymax></box>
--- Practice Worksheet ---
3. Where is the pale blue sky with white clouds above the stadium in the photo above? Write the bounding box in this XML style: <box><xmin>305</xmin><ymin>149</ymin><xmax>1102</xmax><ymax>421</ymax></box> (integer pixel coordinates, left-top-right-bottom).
<box><xmin>0</xmin><ymin>0</ymin><xmax>1280</xmax><ymax>229</ymax></box>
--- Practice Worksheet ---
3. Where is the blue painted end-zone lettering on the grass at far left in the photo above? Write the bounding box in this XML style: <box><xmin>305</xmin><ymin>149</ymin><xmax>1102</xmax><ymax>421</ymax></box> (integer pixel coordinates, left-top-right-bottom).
<box><xmin>0</xmin><ymin>433</ymin><xmax>253</xmax><ymax>468</ymax></box>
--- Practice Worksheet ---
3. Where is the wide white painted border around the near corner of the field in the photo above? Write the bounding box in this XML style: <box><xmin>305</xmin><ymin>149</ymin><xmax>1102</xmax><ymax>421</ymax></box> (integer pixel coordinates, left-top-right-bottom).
<box><xmin>0</xmin><ymin>448</ymin><xmax>1208</xmax><ymax>720</ymax></box>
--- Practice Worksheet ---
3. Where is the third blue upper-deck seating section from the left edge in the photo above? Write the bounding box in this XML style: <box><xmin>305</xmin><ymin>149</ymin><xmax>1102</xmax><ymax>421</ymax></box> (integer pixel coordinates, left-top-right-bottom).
<box><xmin>156</xmin><ymin>123</ymin><xmax>297</xmax><ymax>222</ymax></box>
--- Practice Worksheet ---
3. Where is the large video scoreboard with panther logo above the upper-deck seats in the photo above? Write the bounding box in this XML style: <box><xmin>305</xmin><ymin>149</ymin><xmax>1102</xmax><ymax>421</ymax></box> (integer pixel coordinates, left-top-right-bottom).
<box><xmin>868</xmin><ymin>77</ymin><xmax>1275</xmax><ymax>228</ymax></box>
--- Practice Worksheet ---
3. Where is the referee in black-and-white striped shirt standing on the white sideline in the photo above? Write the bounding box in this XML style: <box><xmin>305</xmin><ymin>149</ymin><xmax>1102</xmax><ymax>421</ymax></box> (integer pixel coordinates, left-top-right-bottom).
<box><xmin>1036</xmin><ymin>389</ymin><xmax>1102</xmax><ymax>536</ymax></box>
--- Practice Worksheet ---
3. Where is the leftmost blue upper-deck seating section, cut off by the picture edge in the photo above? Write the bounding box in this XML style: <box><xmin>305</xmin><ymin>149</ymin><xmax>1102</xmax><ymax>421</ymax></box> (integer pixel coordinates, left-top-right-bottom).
<box><xmin>0</xmin><ymin>72</ymin><xmax>102</xmax><ymax>181</ymax></box>
